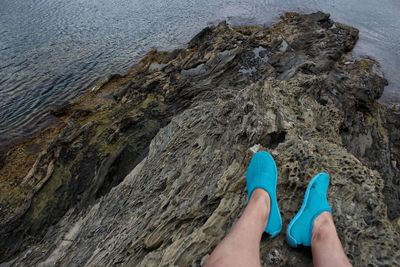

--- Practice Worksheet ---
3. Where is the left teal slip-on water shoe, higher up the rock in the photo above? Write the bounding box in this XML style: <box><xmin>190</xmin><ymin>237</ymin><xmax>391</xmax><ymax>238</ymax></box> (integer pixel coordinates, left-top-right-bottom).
<box><xmin>246</xmin><ymin>151</ymin><xmax>282</xmax><ymax>238</ymax></box>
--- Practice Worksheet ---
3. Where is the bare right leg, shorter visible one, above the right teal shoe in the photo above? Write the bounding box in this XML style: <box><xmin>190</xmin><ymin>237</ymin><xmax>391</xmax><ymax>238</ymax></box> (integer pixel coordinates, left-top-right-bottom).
<box><xmin>311</xmin><ymin>212</ymin><xmax>351</xmax><ymax>267</ymax></box>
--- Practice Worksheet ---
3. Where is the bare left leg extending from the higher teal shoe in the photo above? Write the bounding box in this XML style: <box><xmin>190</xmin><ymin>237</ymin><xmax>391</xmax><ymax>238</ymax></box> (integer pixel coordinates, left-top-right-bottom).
<box><xmin>205</xmin><ymin>189</ymin><xmax>270</xmax><ymax>267</ymax></box>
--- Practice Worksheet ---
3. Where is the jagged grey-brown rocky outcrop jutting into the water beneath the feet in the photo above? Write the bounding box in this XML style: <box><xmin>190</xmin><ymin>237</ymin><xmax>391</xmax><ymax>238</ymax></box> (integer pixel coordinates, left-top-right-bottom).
<box><xmin>0</xmin><ymin>12</ymin><xmax>400</xmax><ymax>266</ymax></box>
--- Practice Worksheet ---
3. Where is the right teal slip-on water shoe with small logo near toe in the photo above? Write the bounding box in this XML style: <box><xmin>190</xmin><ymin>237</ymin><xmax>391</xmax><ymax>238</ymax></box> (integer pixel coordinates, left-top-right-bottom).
<box><xmin>286</xmin><ymin>172</ymin><xmax>332</xmax><ymax>248</ymax></box>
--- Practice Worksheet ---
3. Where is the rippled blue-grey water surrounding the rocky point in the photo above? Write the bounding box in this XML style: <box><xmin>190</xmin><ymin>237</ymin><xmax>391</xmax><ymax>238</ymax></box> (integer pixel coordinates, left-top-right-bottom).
<box><xmin>0</xmin><ymin>0</ymin><xmax>400</xmax><ymax>146</ymax></box>
